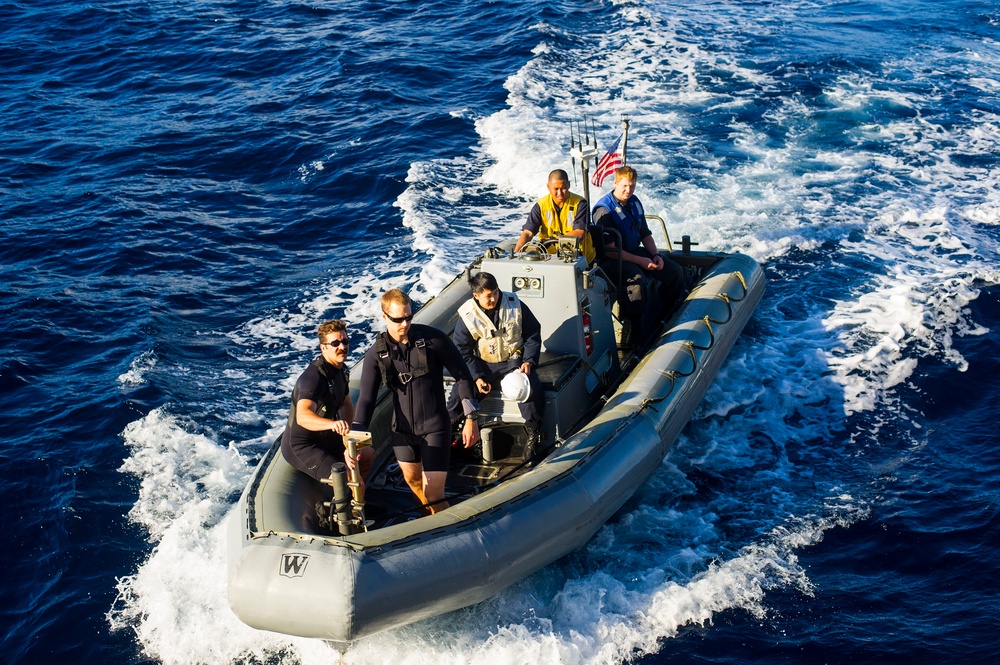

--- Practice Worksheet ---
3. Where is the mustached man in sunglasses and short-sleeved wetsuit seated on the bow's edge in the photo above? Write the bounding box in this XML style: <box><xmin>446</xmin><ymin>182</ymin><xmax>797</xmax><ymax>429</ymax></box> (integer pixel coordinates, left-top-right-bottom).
<box><xmin>281</xmin><ymin>320</ymin><xmax>374</xmax><ymax>488</ymax></box>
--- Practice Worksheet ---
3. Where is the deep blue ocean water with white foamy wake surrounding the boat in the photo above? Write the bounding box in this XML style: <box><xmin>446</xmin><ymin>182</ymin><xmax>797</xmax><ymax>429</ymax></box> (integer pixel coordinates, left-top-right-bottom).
<box><xmin>0</xmin><ymin>0</ymin><xmax>1000</xmax><ymax>665</ymax></box>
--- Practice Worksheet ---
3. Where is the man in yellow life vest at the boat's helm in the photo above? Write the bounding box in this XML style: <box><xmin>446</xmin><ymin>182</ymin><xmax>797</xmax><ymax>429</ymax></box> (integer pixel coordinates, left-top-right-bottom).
<box><xmin>514</xmin><ymin>169</ymin><xmax>596</xmax><ymax>263</ymax></box>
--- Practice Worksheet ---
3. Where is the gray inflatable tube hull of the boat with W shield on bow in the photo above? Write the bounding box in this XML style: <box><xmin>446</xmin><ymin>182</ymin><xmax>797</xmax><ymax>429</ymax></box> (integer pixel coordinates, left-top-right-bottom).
<box><xmin>229</xmin><ymin>255</ymin><xmax>764</xmax><ymax>642</ymax></box>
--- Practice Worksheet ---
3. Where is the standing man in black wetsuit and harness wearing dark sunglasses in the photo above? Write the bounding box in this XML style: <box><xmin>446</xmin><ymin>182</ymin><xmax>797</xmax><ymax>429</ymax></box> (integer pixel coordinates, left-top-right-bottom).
<box><xmin>354</xmin><ymin>289</ymin><xmax>479</xmax><ymax>513</ymax></box>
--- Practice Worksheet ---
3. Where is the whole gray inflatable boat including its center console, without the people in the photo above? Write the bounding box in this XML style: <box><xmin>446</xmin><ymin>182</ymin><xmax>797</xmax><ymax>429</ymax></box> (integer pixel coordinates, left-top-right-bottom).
<box><xmin>228</xmin><ymin>236</ymin><xmax>764</xmax><ymax>642</ymax></box>
